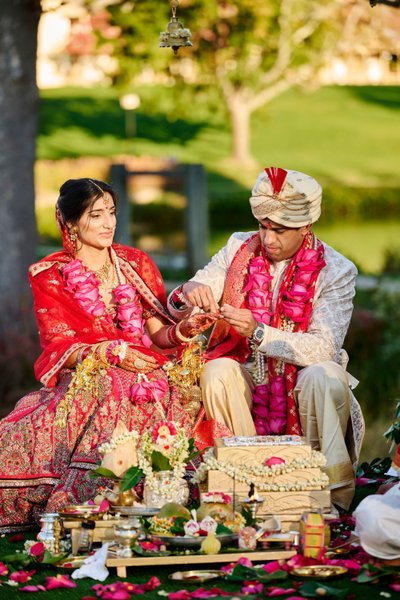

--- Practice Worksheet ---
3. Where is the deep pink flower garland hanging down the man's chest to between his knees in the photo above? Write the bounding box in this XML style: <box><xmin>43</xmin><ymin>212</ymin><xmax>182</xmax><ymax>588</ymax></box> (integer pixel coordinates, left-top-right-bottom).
<box><xmin>243</xmin><ymin>240</ymin><xmax>325</xmax><ymax>435</ymax></box>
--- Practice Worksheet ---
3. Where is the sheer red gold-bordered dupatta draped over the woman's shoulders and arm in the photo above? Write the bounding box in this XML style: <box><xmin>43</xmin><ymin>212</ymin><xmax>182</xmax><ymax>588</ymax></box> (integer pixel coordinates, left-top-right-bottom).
<box><xmin>29</xmin><ymin>244</ymin><xmax>173</xmax><ymax>387</ymax></box>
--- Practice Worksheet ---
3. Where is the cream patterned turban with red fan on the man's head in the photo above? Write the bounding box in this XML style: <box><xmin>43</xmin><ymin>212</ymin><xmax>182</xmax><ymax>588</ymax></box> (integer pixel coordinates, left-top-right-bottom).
<box><xmin>250</xmin><ymin>167</ymin><xmax>322</xmax><ymax>227</ymax></box>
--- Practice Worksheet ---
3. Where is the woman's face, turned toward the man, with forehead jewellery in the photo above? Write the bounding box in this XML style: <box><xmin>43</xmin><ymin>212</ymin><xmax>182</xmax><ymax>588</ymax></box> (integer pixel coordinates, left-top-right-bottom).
<box><xmin>77</xmin><ymin>192</ymin><xmax>117</xmax><ymax>250</ymax></box>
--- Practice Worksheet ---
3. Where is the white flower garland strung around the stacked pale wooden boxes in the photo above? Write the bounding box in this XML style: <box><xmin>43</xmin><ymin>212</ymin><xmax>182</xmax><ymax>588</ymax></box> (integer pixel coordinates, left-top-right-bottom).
<box><xmin>194</xmin><ymin>449</ymin><xmax>329</xmax><ymax>492</ymax></box>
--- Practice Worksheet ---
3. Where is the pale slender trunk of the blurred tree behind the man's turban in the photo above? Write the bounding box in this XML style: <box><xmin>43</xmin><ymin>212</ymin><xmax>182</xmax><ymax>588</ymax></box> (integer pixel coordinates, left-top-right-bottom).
<box><xmin>227</xmin><ymin>92</ymin><xmax>255</xmax><ymax>166</ymax></box>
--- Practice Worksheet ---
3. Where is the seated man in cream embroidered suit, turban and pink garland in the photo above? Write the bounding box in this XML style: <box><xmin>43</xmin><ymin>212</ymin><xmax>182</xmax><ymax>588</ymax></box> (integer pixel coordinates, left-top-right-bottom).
<box><xmin>169</xmin><ymin>168</ymin><xmax>363</xmax><ymax>508</ymax></box>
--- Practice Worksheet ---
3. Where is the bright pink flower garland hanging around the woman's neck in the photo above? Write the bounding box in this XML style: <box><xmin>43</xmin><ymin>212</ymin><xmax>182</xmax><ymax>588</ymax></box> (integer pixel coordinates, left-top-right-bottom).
<box><xmin>63</xmin><ymin>258</ymin><xmax>151</xmax><ymax>347</ymax></box>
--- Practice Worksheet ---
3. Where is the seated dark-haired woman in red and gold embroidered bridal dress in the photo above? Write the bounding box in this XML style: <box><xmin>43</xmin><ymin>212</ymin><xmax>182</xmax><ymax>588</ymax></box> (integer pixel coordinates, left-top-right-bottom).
<box><xmin>0</xmin><ymin>178</ymin><xmax>217</xmax><ymax>532</ymax></box>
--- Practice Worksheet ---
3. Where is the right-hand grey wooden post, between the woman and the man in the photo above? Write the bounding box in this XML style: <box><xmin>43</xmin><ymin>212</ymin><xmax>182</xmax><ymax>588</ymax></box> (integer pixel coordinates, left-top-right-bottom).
<box><xmin>185</xmin><ymin>164</ymin><xmax>208</xmax><ymax>276</ymax></box>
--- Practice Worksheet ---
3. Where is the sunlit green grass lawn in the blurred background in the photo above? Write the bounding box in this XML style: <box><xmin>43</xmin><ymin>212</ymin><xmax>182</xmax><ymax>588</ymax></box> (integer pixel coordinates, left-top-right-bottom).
<box><xmin>38</xmin><ymin>86</ymin><xmax>400</xmax><ymax>187</ymax></box>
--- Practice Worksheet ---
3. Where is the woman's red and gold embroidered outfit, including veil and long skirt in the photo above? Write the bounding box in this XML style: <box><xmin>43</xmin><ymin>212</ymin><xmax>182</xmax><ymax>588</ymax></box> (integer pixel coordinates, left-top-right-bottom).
<box><xmin>0</xmin><ymin>245</ymin><xmax>191</xmax><ymax>531</ymax></box>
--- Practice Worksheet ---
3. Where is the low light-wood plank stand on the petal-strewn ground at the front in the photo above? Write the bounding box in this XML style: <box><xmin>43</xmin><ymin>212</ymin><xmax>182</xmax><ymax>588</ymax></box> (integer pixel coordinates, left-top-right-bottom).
<box><xmin>106</xmin><ymin>550</ymin><xmax>296</xmax><ymax>577</ymax></box>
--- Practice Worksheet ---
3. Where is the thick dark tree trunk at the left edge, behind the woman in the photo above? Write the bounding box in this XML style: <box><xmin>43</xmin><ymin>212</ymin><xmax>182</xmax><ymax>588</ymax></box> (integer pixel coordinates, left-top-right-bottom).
<box><xmin>0</xmin><ymin>0</ymin><xmax>41</xmax><ymax>344</ymax></box>
